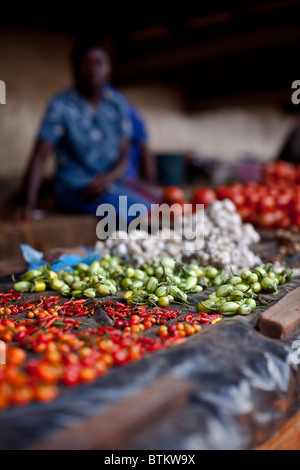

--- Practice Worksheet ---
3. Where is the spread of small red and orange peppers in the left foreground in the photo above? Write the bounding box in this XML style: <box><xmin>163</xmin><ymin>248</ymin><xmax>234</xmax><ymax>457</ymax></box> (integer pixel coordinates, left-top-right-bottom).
<box><xmin>0</xmin><ymin>289</ymin><xmax>221</xmax><ymax>409</ymax></box>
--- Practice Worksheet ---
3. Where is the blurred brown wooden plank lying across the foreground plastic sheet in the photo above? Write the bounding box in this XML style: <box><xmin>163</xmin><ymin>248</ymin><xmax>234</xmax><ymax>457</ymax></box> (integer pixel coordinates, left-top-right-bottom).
<box><xmin>28</xmin><ymin>376</ymin><xmax>190</xmax><ymax>450</ymax></box>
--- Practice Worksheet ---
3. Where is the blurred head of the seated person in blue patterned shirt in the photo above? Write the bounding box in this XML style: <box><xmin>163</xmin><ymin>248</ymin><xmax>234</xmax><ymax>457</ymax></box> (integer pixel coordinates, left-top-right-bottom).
<box><xmin>71</xmin><ymin>37</ymin><xmax>111</xmax><ymax>90</ymax></box>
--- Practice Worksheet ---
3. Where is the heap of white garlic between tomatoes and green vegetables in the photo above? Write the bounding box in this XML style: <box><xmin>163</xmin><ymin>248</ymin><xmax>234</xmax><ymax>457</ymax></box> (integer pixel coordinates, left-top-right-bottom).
<box><xmin>96</xmin><ymin>200</ymin><xmax>262</xmax><ymax>272</ymax></box>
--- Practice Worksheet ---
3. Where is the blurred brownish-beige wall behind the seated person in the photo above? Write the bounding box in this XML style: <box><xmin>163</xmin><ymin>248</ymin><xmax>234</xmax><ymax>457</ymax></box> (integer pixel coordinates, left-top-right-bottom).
<box><xmin>0</xmin><ymin>29</ymin><xmax>298</xmax><ymax>183</ymax></box>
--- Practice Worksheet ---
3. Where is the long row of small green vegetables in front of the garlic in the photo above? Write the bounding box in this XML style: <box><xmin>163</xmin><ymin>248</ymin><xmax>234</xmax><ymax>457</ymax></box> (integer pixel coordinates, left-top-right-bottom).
<box><xmin>14</xmin><ymin>255</ymin><xmax>293</xmax><ymax>315</ymax></box>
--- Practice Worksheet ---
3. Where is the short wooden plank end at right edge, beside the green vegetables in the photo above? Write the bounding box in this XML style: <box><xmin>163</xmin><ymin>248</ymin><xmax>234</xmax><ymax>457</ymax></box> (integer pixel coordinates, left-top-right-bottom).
<box><xmin>257</xmin><ymin>287</ymin><xmax>300</xmax><ymax>338</ymax></box>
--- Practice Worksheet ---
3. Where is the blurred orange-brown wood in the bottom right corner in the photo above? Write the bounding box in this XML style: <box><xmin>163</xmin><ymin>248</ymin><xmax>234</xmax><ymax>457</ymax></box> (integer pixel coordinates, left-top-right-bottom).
<box><xmin>259</xmin><ymin>411</ymin><xmax>300</xmax><ymax>450</ymax></box>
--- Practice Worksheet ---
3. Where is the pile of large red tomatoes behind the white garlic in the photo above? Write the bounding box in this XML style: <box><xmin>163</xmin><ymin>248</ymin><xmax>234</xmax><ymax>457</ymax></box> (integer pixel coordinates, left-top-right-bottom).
<box><xmin>165</xmin><ymin>161</ymin><xmax>300</xmax><ymax>229</ymax></box>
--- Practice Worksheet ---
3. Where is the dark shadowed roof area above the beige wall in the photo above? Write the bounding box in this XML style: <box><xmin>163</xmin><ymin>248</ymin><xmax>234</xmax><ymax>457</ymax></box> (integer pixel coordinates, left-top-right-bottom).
<box><xmin>0</xmin><ymin>0</ymin><xmax>300</xmax><ymax>111</ymax></box>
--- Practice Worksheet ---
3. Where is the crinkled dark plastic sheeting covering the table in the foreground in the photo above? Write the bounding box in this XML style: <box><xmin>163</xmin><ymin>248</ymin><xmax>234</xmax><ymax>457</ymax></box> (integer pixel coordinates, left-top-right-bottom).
<box><xmin>0</xmin><ymin>279</ymin><xmax>300</xmax><ymax>450</ymax></box>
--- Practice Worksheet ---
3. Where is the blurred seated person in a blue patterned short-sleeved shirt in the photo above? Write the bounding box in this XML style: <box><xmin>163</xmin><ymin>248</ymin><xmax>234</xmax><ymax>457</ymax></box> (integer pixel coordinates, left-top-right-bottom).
<box><xmin>11</xmin><ymin>38</ymin><xmax>157</xmax><ymax>225</ymax></box>
